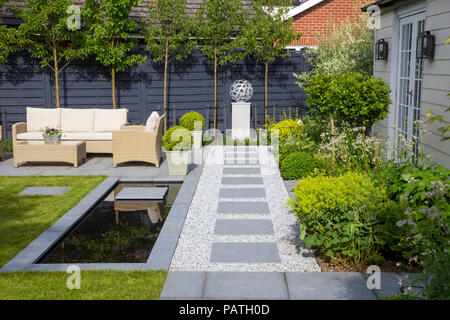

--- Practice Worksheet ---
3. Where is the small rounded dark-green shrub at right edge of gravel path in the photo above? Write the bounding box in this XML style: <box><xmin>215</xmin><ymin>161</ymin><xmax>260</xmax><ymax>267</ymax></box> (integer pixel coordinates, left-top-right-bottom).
<box><xmin>281</xmin><ymin>152</ymin><xmax>316</xmax><ymax>180</ymax></box>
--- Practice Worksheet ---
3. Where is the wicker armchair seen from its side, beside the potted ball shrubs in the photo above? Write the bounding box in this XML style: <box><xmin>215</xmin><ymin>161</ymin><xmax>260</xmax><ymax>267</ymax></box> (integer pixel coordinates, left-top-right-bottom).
<box><xmin>113</xmin><ymin>116</ymin><xmax>165</xmax><ymax>168</ymax></box>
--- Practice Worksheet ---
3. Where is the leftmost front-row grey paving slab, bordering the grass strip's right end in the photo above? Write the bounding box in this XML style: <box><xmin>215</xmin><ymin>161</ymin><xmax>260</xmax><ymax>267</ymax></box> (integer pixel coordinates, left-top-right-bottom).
<box><xmin>159</xmin><ymin>272</ymin><xmax>206</xmax><ymax>299</ymax></box>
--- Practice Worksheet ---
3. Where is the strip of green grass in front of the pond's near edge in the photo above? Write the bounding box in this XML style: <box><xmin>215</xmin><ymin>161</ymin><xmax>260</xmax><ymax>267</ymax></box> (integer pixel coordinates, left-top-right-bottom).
<box><xmin>0</xmin><ymin>271</ymin><xmax>167</xmax><ymax>300</ymax></box>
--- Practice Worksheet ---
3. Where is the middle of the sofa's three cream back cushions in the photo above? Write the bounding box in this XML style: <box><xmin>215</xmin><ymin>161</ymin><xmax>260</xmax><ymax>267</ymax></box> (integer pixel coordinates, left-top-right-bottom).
<box><xmin>61</xmin><ymin>108</ymin><xmax>94</xmax><ymax>132</ymax></box>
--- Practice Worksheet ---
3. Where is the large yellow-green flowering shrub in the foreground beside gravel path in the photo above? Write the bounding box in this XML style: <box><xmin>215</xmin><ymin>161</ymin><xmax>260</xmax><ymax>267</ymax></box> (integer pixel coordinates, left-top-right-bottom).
<box><xmin>289</xmin><ymin>171</ymin><xmax>386</xmax><ymax>264</ymax></box>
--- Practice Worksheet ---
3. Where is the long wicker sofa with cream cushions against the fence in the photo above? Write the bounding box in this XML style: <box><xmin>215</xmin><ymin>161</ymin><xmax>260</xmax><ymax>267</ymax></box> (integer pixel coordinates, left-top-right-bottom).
<box><xmin>12</xmin><ymin>108</ymin><xmax>128</xmax><ymax>153</ymax></box>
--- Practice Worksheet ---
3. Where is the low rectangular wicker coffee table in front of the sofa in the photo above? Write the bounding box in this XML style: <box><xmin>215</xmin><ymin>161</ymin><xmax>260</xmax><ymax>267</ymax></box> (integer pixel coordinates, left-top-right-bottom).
<box><xmin>13</xmin><ymin>141</ymin><xmax>86</xmax><ymax>168</ymax></box>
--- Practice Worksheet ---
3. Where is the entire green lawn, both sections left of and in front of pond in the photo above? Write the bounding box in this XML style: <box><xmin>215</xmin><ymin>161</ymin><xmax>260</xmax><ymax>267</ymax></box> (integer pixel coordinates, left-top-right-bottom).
<box><xmin>0</xmin><ymin>176</ymin><xmax>167</xmax><ymax>300</ymax></box>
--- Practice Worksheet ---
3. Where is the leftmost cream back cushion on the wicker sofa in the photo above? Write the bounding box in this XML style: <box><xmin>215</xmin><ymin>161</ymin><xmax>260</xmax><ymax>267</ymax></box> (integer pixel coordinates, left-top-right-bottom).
<box><xmin>27</xmin><ymin>107</ymin><xmax>61</xmax><ymax>132</ymax></box>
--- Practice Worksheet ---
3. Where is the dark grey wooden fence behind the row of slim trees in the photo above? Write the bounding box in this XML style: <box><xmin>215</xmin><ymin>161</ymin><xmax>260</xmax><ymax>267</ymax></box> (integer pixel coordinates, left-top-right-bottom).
<box><xmin>0</xmin><ymin>47</ymin><xmax>309</xmax><ymax>138</ymax></box>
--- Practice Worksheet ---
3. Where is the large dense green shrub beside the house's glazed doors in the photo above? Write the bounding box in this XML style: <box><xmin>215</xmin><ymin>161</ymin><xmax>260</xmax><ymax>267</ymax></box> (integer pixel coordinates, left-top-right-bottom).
<box><xmin>305</xmin><ymin>72</ymin><xmax>391</xmax><ymax>128</ymax></box>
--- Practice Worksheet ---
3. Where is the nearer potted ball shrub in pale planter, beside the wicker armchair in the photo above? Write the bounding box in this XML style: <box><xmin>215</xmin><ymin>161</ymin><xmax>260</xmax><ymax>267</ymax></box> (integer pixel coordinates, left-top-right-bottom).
<box><xmin>162</xmin><ymin>126</ymin><xmax>192</xmax><ymax>176</ymax></box>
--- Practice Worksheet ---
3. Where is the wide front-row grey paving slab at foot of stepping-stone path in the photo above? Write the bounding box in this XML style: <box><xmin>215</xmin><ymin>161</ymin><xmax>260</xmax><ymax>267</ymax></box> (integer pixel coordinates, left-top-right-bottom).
<box><xmin>204</xmin><ymin>272</ymin><xmax>288</xmax><ymax>300</ymax></box>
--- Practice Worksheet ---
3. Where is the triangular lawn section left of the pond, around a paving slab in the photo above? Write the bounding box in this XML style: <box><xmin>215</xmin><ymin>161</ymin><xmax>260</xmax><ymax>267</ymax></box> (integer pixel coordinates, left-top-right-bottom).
<box><xmin>0</xmin><ymin>176</ymin><xmax>105</xmax><ymax>267</ymax></box>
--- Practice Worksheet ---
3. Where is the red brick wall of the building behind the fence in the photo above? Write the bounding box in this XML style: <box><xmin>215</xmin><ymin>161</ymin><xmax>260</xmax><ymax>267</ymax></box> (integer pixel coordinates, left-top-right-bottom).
<box><xmin>292</xmin><ymin>0</ymin><xmax>373</xmax><ymax>46</ymax></box>
